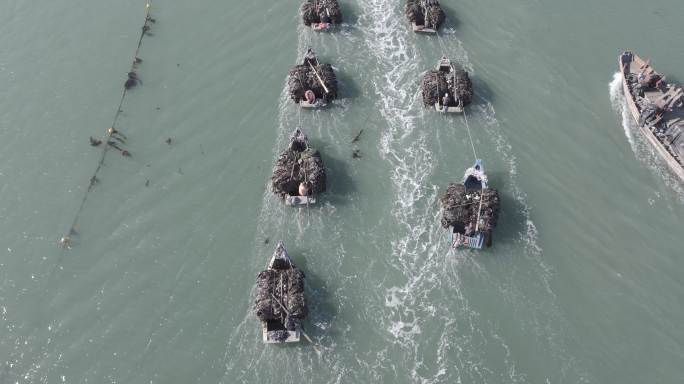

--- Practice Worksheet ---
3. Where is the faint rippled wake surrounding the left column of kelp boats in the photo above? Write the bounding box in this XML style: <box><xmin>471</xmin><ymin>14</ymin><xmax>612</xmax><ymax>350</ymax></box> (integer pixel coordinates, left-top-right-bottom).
<box><xmin>221</xmin><ymin>25</ymin><xmax>376</xmax><ymax>383</ymax></box>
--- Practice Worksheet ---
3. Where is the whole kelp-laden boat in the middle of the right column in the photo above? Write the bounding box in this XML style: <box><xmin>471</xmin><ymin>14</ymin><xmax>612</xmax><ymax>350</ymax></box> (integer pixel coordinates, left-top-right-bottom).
<box><xmin>422</xmin><ymin>56</ymin><xmax>473</xmax><ymax>113</ymax></box>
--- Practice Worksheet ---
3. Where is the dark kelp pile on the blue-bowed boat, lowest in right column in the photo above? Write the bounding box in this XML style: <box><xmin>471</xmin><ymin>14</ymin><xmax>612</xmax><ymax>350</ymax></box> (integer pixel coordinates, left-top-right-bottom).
<box><xmin>440</xmin><ymin>183</ymin><xmax>499</xmax><ymax>235</ymax></box>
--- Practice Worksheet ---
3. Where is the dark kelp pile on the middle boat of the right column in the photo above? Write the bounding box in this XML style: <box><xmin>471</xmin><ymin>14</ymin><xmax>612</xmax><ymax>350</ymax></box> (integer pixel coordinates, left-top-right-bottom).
<box><xmin>422</xmin><ymin>68</ymin><xmax>473</xmax><ymax>107</ymax></box>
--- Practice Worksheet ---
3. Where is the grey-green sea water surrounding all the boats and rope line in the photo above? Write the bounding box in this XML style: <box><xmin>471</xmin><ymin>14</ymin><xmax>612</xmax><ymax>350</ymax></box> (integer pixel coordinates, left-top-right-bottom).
<box><xmin>0</xmin><ymin>0</ymin><xmax>684</xmax><ymax>384</ymax></box>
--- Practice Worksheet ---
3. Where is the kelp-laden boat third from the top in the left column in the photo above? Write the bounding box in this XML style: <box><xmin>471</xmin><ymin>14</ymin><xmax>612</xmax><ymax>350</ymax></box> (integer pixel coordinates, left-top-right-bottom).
<box><xmin>271</xmin><ymin>129</ymin><xmax>326</xmax><ymax>198</ymax></box>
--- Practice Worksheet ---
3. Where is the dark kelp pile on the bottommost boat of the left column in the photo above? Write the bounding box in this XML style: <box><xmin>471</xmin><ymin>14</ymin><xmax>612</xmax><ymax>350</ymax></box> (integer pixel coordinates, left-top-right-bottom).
<box><xmin>254</xmin><ymin>268</ymin><xmax>308</xmax><ymax>324</ymax></box>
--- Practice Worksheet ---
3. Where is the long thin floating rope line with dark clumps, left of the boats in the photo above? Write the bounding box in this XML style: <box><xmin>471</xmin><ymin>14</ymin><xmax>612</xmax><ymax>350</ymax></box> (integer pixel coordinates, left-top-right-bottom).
<box><xmin>59</xmin><ymin>0</ymin><xmax>156</xmax><ymax>249</ymax></box>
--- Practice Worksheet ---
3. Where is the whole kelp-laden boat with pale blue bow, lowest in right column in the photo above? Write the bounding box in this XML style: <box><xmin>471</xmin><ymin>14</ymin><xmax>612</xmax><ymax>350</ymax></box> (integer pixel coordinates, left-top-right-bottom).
<box><xmin>440</xmin><ymin>160</ymin><xmax>499</xmax><ymax>249</ymax></box>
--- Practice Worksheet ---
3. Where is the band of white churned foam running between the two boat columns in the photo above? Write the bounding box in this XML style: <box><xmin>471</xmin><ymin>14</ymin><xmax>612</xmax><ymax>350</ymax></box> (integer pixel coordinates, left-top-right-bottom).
<box><xmin>361</xmin><ymin>0</ymin><xmax>540</xmax><ymax>383</ymax></box>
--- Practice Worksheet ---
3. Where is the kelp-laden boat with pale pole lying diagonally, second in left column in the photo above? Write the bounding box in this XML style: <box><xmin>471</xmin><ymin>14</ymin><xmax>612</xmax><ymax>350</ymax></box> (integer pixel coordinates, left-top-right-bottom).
<box><xmin>287</xmin><ymin>48</ymin><xmax>337</xmax><ymax>108</ymax></box>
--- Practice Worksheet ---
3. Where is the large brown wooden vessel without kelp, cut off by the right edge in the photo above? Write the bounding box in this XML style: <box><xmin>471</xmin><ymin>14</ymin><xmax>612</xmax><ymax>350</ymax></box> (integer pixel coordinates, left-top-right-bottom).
<box><xmin>619</xmin><ymin>51</ymin><xmax>684</xmax><ymax>181</ymax></box>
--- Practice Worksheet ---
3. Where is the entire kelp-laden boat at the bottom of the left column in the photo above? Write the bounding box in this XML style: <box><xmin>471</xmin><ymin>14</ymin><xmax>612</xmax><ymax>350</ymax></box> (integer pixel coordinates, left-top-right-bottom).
<box><xmin>254</xmin><ymin>242</ymin><xmax>308</xmax><ymax>344</ymax></box>
